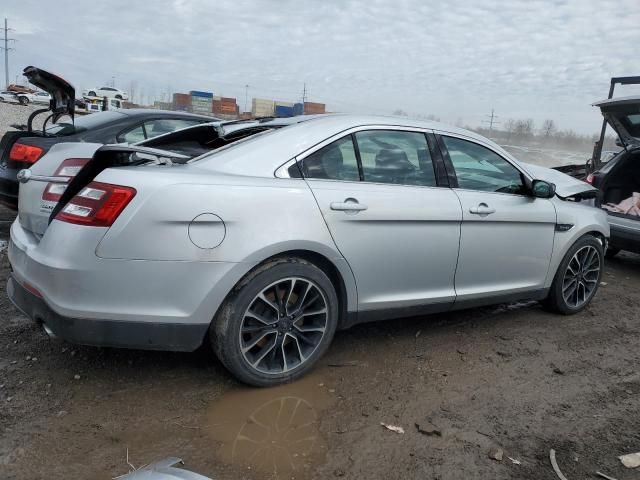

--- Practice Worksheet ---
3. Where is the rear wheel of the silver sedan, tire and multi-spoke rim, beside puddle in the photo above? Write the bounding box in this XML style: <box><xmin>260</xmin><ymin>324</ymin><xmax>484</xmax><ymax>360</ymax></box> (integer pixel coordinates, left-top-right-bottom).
<box><xmin>209</xmin><ymin>257</ymin><xmax>339</xmax><ymax>387</ymax></box>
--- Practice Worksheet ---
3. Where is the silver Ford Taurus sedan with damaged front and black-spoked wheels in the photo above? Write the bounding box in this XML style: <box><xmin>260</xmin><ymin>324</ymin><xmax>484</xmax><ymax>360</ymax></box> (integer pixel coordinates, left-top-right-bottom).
<box><xmin>8</xmin><ymin>115</ymin><xmax>609</xmax><ymax>386</ymax></box>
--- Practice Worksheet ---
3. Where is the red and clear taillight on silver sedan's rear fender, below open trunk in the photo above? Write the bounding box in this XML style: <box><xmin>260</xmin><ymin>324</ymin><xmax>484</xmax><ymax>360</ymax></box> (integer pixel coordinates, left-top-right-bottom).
<box><xmin>56</xmin><ymin>182</ymin><xmax>136</xmax><ymax>227</ymax></box>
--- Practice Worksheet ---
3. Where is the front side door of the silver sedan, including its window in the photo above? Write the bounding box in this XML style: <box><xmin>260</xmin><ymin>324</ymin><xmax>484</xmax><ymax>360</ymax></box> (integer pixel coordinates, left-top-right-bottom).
<box><xmin>438</xmin><ymin>134</ymin><xmax>556</xmax><ymax>305</ymax></box>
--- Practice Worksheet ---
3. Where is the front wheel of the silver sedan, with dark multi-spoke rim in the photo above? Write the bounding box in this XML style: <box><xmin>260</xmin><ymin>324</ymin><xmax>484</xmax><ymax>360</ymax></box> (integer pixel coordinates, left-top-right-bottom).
<box><xmin>543</xmin><ymin>235</ymin><xmax>604</xmax><ymax>315</ymax></box>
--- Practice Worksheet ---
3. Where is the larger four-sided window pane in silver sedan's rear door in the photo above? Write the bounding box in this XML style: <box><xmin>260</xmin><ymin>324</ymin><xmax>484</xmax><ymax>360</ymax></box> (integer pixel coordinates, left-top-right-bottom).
<box><xmin>356</xmin><ymin>130</ymin><xmax>436</xmax><ymax>187</ymax></box>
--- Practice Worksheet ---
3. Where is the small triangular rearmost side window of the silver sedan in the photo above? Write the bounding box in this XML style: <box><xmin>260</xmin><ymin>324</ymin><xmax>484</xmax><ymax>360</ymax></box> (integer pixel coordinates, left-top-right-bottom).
<box><xmin>301</xmin><ymin>135</ymin><xmax>360</xmax><ymax>182</ymax></box>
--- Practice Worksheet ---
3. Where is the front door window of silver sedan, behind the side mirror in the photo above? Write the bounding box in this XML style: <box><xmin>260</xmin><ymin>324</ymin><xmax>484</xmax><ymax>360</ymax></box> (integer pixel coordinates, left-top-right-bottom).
<box><xmin>442</xmin><ymin>136</ymin><xmax>525</xmax><ymax>193</ymax></box>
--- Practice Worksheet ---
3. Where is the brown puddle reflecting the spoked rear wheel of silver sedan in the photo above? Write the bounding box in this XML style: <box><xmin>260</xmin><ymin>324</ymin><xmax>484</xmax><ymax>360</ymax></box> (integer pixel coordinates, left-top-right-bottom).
<box><xmin>209</xmin><ymin>375</ymin><xmax>334</xmax><ymax>478</ymax></box>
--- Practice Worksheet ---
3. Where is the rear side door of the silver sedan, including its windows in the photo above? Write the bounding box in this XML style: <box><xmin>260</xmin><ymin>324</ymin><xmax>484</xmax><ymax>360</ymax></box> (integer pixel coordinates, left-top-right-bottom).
<box><xmin>299</xmin><ymin>127</ymin><xmax>462</xmax><ymax>317</ymax></box>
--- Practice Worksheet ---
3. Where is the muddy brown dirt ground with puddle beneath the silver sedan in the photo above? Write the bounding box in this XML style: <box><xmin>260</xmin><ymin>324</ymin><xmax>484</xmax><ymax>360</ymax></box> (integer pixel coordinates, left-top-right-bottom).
<box><xmin>0</xmin><ymin>203</ymin><xmax>640</xmax><ymax>480</ymax></box>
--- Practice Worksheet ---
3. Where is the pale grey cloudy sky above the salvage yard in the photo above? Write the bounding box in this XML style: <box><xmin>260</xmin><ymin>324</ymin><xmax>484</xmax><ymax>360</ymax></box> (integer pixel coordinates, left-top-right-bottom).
<box><xmin>5</xmin><ymin>0</ymin><xmax>640</xmax><ymax>133</ymax></box>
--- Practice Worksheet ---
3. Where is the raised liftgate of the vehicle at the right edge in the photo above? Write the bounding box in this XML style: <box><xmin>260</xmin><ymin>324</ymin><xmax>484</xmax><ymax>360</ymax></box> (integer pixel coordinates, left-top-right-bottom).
<box><xmin>593</xmin><ymin>96</ymin><xmax>640</xmax><ymax>150</ymax></box>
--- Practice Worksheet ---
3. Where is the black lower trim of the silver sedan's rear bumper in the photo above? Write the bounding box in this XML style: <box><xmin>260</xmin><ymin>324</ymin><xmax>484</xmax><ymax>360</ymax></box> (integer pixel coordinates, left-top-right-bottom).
<box><xmin>7</xmin><ymin>275</ymin><xmax>207</xmax><ymax>351</ymax></box>
